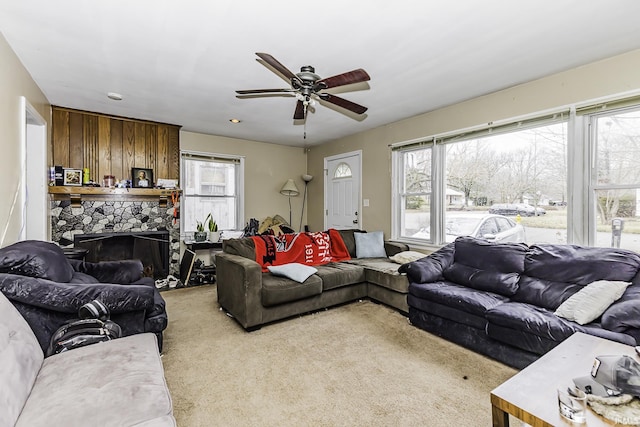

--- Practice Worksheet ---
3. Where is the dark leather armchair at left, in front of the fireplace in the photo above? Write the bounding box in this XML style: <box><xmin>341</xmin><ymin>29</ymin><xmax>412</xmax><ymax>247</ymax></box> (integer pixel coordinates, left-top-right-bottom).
<box><xmin>0</xmin><ymin>240</ymin><xmax>167</xmax><ymax>351</ymax></box>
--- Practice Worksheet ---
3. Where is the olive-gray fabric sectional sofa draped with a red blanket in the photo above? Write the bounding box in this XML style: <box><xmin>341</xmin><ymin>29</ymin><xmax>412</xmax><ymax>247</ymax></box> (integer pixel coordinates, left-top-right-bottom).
<box><xmin>216</xmin><ymin>230</ymin><xmax>409</xmax><ymax>330</ymax></box>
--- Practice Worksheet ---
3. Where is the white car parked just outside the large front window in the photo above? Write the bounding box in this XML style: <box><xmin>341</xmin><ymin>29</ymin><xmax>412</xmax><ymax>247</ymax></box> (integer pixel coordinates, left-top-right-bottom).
<box><xmin>412</xmin><ymin>213</ymin><xmax>526</xmax><ymax>243</ymax></box>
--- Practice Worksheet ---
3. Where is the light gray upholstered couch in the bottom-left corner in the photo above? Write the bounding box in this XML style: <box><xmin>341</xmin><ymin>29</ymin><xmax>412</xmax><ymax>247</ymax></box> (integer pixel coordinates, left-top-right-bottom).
<box><xmin>0</xmin><ymin>293</ymin><xmax>176</xmax><ymax>427</ymax></box>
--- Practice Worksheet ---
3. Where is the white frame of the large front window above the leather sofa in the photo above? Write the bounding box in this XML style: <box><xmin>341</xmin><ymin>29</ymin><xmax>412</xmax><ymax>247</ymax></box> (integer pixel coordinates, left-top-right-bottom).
<box><xmin>389</xmin><ymin>96</ymin><xmax>640</xmax><ymax>249</ymax></box>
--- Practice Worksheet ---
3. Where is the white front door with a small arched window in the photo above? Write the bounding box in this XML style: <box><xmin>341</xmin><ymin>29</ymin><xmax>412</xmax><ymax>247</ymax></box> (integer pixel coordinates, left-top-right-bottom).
<box><xmin>324</xmin><ymin>151</ymin><xmax>362</xmax><ymax>230</ymax></box>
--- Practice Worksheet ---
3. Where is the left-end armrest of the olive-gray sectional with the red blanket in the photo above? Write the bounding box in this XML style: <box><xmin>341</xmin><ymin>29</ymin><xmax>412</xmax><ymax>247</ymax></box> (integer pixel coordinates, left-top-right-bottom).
<box><xmin>216</xmin><ymin>252</ymin><xmax>263</xmax><ymax>329</ymax></box>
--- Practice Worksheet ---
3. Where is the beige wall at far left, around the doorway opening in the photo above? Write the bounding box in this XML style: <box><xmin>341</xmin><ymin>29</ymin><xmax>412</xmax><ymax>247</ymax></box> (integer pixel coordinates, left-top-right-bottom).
<box><xmin>0</xmin><ymin>33</ymin><xmax>51</xmax><ymax>246</ymax></box>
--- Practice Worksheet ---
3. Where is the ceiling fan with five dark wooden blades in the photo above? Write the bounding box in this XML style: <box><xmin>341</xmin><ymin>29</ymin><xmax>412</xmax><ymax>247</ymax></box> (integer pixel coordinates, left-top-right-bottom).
<box><xmin>236</xmin><ymin>52</ymin><xmax>371</xmax><ymax>120</ymax></box>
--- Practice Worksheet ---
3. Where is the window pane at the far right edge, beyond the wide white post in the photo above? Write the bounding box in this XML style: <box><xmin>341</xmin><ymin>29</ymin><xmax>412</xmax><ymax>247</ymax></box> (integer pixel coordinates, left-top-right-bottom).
<box><xmin>588</xmin><ymin>107</ymin><xmax>640</xmax><ymax>251</ymax></box>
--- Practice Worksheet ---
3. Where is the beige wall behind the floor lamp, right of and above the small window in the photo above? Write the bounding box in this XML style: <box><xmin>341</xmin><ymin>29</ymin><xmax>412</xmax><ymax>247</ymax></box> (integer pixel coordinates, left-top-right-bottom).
<box><xmin>180</xmin><ymin>131</ymin><xmax>307</xmax><ymax>230</ymax></box>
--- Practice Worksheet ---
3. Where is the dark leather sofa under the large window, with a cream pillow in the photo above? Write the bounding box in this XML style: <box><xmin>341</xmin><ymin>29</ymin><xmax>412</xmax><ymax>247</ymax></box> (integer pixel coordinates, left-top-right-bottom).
<box><xmin>400</xmin><ymin>237</ymin><xmax>640</xmax><ymax>368</ymax></box>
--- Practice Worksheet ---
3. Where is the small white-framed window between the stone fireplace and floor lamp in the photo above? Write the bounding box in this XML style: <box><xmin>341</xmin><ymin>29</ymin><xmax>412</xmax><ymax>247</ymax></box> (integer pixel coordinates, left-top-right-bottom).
<box><xmin>180</xmin><ymin>152</ymin><xmax>244</xmax><ymax>233</ymax></box>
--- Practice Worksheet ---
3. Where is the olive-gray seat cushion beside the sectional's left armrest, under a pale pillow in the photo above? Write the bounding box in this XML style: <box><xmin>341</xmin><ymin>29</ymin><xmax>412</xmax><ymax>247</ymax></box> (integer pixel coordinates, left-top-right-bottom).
<box><xmin>261</xmin><ymin>273</ymin><xmax>322</xmax><ymax>307</ymax></box>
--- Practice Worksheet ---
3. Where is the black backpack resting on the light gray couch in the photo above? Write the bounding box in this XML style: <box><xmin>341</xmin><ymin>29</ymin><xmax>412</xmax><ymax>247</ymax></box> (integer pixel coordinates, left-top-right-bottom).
<box><xmin>45</xmin><ymin>300</ymin><xmax>122</xmax><ymax>357</ymax></box>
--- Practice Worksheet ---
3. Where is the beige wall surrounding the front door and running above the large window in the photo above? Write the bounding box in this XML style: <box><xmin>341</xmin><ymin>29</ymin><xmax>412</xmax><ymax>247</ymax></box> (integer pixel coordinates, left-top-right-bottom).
<box><xmin>307</xmin><ymin>50</ymin><xmax>640</xmax><ymax>237</ymax></box>
